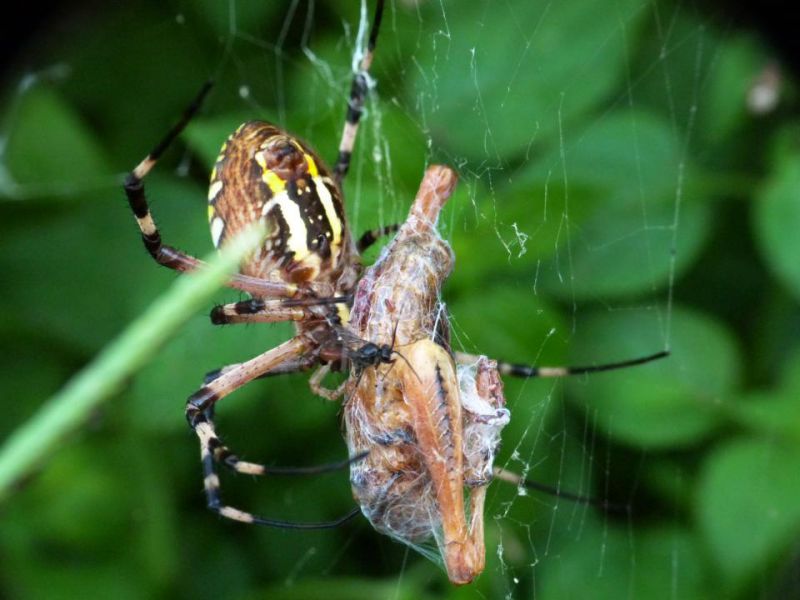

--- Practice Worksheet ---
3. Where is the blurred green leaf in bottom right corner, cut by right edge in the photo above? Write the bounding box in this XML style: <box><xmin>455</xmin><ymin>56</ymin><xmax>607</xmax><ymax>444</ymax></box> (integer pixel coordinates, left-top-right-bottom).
<box><xmin>696</xmin><ymin>438</ymin><xmax>800</xmax><ymax>587</ymax></box>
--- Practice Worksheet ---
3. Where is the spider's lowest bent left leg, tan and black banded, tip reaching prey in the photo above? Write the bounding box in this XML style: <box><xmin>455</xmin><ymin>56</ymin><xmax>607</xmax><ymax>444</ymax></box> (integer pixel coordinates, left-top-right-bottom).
<box><xmin>186</xmin><ymin>336</ymin><xmax>358</xmax><ymax>529</ymax></box>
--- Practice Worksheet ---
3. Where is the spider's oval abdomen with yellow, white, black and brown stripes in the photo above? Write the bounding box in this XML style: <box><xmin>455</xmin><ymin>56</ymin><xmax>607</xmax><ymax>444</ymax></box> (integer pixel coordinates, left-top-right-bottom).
<box><xmin>208</xmin><ymin>121</ymin><xmax>350</xmax><ymax>283</ymax></box>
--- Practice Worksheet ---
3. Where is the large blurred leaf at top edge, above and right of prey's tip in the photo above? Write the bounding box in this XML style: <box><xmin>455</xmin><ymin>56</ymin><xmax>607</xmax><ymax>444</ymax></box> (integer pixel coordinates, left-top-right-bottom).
<box><xmin>409</xmin><ymin>1</ymin><xmax>647</xmax><ymax>165</ymax></box>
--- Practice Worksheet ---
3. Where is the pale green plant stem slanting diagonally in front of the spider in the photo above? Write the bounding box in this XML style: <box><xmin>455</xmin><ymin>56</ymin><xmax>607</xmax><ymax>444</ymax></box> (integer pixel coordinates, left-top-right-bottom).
<box><xmin>0</xmin><ymin>227</ymin><xmax>264</xmax><ymax>501</ymax></box>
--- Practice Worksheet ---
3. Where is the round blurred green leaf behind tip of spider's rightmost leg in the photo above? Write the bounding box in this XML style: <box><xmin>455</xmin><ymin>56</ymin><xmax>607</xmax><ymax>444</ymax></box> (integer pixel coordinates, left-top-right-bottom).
<box><xmin>568</xmin><ymin>307</ymin><xmax>742</xmax><ymax>449</ymax></box>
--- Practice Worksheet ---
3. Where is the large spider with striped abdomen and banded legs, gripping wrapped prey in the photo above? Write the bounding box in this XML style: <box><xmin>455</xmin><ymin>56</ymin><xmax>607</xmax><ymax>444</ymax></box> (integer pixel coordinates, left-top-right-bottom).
<box><xmin>124</xmin><ymin>0</ymin><xmax>666</xmax><ymax>564</ymax></box>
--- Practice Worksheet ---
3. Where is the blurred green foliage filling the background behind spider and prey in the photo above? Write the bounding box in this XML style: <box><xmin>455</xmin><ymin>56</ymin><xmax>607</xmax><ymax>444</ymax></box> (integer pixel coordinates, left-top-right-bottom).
<box><xmin>0</xmin><ymin>0</ymin><xmax>800</xmax><ymax>600</ymax></box>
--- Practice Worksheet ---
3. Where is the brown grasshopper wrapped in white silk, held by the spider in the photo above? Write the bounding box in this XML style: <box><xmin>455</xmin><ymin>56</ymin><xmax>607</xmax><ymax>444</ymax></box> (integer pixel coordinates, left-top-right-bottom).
<box><xmin>344</xmin><ymin>166</ymin><xmax>510</xmax><ymax>584</ymax></box>
